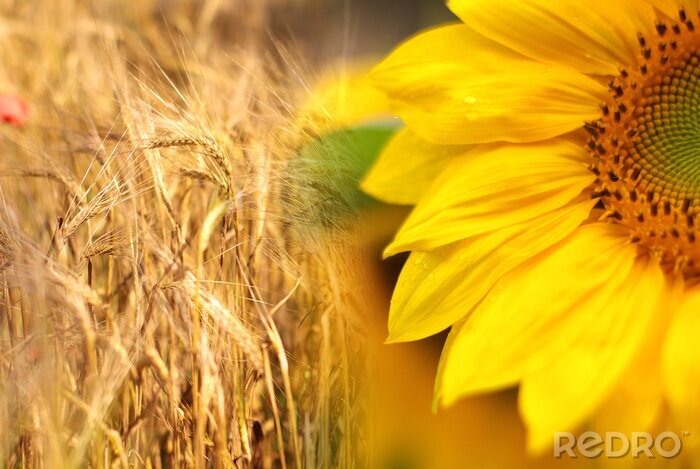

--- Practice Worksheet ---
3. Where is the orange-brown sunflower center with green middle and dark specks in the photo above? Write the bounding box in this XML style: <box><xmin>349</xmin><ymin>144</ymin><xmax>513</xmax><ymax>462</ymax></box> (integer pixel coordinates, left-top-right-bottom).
<box><xmin>585</xmin><ymin>9</ymin><xmax>700</xmax><ymax>278</ymax></box>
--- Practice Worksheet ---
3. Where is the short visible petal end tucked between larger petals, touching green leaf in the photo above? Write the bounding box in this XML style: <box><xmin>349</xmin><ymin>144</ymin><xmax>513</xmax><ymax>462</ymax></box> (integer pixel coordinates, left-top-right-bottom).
<box><xmin>362</xmin><ymin>129</ymin><xmax>469</xmax><ymax>205</ymax></box>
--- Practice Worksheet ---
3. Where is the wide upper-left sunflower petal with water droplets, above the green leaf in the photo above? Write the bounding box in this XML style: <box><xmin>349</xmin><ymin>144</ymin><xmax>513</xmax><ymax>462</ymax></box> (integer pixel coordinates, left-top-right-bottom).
<box><xmin>371</xmin><ymin>25</ymin><xmax>607</xmax><ymax>144</ymax></box>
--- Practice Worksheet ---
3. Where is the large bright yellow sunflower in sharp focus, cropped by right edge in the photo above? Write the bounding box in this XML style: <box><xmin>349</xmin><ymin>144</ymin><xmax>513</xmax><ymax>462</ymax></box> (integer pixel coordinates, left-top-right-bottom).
<box><xmin>363</xmin><ymin>0</ymin><xmax>700</xmax><ymax>456</ymax></box>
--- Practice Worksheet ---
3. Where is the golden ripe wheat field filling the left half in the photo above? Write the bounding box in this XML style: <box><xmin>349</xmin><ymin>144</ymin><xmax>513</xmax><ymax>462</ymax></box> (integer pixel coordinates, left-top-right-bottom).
<box><xmin>0</xmin><ymin>0</ymin><xmax>369</xmax><ymax>468</ymax></box>
